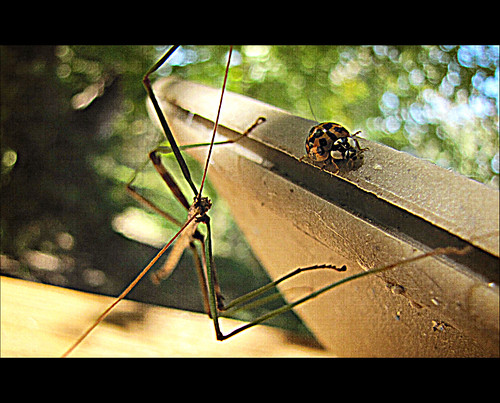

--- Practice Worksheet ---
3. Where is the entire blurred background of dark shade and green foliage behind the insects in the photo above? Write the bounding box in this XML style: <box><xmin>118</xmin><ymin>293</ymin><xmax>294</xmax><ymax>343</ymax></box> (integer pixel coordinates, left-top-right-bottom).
<box><xmin>0</xmin><ymin>45</ymin><xmax>499</xmax><ymax>338</ymax></box>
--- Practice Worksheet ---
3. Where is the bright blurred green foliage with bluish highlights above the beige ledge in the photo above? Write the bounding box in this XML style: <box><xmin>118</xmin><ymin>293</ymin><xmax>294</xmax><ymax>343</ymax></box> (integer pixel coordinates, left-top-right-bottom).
<box><xmin>162</xmin><ymin>45</ymin><xmax>499</xmax><ymax>188</ymax></box>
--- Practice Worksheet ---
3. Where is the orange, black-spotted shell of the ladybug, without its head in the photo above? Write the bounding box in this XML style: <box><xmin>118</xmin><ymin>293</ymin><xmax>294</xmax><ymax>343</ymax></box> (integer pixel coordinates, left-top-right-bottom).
<box><xmin>306</xmin><ymin>122</ymin><xmax>350</xmax><ymax>161</ymax></box>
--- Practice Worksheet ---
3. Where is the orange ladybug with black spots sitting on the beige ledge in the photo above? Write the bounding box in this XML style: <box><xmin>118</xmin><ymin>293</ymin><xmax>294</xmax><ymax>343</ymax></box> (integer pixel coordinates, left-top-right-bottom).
<box><xmin>306</xmin><ymin>122</ymin><xmax>366</xmax><ymax>171</ymax></box>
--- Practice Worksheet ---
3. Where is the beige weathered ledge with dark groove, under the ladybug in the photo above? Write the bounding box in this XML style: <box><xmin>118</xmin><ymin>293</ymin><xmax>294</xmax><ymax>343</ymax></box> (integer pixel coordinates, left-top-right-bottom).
<box><xmin>151</xmin><ymin>78</ymin><xmax>499</xmax><ymax>357</ymax></box>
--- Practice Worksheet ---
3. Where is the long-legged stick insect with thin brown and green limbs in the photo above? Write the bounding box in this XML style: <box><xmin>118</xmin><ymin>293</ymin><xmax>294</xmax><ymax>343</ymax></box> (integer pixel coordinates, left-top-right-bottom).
<box><xmin>63</xmin><ymin>46</ymin><xmax>478</xmax><ymax>357</ymax></box>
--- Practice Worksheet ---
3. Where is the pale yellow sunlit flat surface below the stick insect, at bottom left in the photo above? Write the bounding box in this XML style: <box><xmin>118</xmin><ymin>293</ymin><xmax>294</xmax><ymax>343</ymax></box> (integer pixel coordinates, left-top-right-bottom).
<box><xmin>1</xmin><ymin>277</ymin><xmax>332</xmax><ymax>357</ymax></box>
